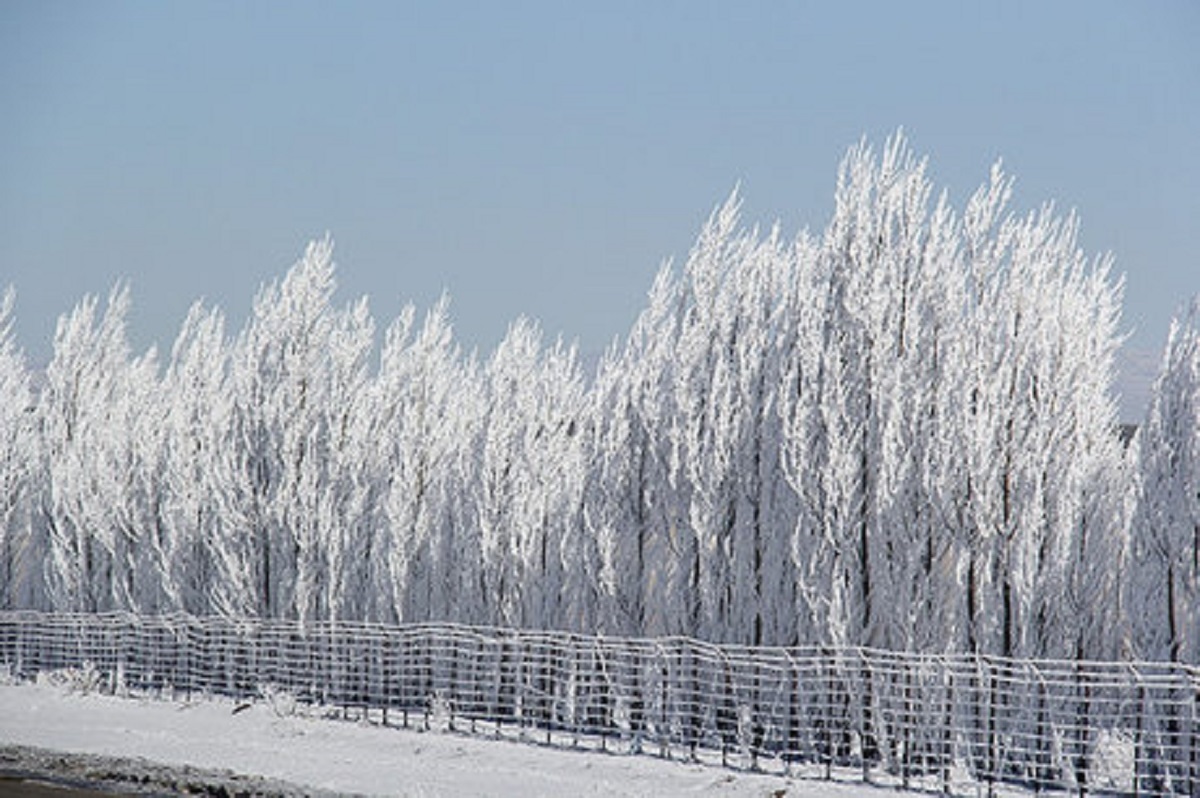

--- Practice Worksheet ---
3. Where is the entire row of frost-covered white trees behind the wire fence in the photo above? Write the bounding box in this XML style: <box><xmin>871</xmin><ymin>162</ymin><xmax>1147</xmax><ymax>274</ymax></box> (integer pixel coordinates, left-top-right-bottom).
<box><xmin>0</xmin><ymin>137</ymin><xmax>1200</xmax><ymax>662</ymax></box>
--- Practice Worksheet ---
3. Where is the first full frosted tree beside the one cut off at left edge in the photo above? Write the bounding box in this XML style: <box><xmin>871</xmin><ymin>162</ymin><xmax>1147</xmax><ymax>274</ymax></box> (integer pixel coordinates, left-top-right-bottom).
<box><xmin>37</xmin><ymin>289</ymin><xmax>157</xmax><ymax>611</ymax></box>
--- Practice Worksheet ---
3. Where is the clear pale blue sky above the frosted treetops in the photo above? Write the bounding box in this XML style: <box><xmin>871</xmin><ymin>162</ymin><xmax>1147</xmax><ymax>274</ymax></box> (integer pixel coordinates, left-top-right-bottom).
<box><xmin>0</xmin><ymin>0</ymin><xmax>1200</xmax><ymax>417</ymax></box>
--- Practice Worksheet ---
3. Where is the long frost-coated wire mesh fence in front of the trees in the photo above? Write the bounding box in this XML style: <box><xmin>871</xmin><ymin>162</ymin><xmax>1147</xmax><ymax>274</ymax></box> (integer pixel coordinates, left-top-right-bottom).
<box><xmin>0</xmin><ymin>612</ymin><xmax>1200</xmax><ymax>796</ymax></box>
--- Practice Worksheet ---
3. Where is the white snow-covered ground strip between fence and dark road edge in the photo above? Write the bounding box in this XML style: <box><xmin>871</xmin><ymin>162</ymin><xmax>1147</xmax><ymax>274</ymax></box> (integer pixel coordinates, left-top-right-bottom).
<box><xmin>0</xmin><ymin>683</ymin><xmax>896</xmax><ymax>798</ymax></box>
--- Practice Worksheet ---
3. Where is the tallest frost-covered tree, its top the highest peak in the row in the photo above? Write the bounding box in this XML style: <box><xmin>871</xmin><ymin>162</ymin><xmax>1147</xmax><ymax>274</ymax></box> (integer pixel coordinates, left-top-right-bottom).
<box><xmin>821</xmin><ymin>136</ymin><xmax>964</xmax><ymax>648</ymax></box>
